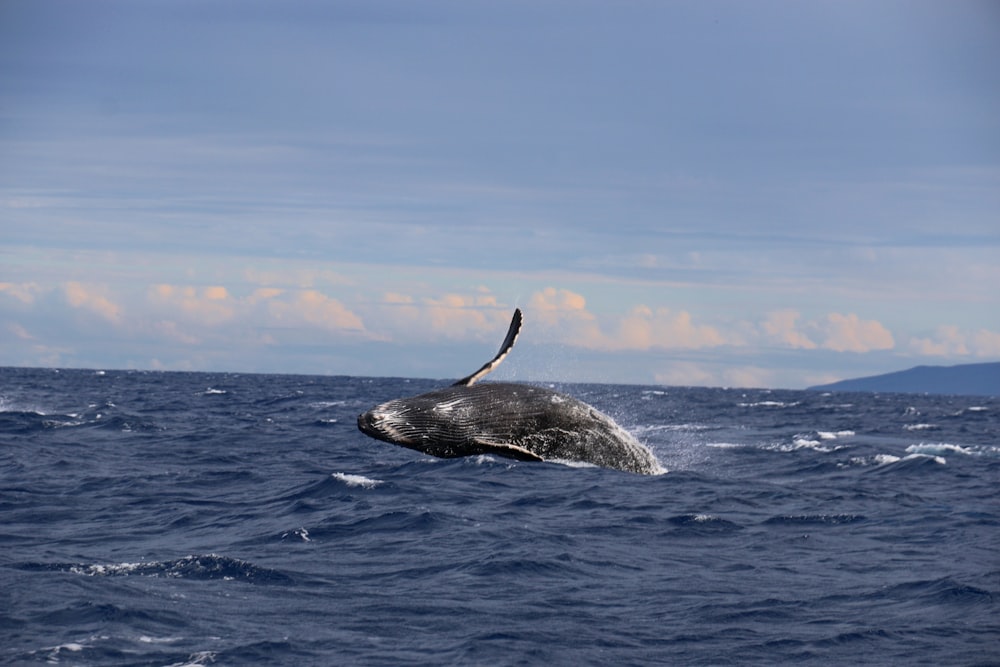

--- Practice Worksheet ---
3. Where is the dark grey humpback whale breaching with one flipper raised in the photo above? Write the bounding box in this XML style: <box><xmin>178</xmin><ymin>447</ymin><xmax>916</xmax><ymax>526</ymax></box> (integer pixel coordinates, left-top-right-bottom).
<box><xmin>358</xmin><ymin>309</ymin><xmax>664</xmax><ymax>475</ymax></box>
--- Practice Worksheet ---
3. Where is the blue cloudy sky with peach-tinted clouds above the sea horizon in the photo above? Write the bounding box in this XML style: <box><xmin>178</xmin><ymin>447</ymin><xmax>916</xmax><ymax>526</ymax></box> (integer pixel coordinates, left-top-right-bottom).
<box><xmin>0</xmin><ymin>0</ymin><xmax>1000</xmax><ymax>389</ymax></box>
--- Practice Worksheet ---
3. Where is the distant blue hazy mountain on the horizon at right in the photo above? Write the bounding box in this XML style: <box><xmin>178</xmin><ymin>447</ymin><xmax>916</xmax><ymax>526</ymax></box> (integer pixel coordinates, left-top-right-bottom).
<box><xmin>808</xmin><ymin>362</ymin><xmax>1000</xmax><ymax>396</ymax></box>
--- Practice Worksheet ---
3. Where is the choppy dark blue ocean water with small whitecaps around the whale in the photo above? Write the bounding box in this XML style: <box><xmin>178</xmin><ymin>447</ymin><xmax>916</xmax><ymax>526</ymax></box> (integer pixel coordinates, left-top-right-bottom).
<box><xmin>0</xmin><ymin>368</ymin><xmax>1000</xmax><ymax>665</ymax></box>
